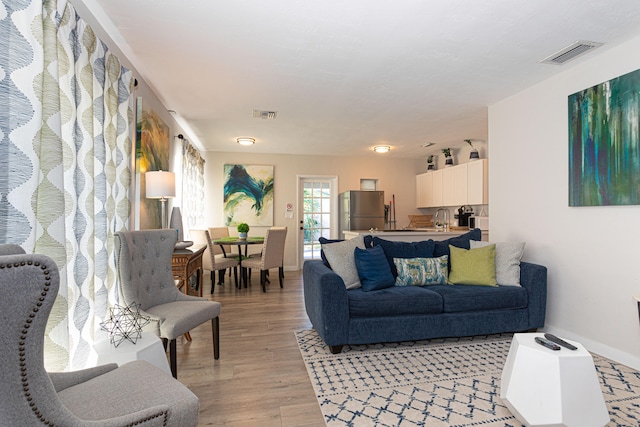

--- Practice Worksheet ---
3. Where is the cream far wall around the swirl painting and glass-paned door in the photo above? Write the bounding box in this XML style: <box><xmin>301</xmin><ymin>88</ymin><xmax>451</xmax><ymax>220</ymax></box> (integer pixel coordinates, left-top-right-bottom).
<box><xmin>202</xmin><ymin>152</ymin><xmax>426</xmax><ymax>270</ymax></box>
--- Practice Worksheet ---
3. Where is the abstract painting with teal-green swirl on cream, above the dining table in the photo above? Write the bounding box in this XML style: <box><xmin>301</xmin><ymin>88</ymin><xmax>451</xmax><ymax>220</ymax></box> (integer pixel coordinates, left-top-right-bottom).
<box><xmin>224</xmin><ymin>165</ymin><xmax>273</xmax><ymax>227</ymax></box>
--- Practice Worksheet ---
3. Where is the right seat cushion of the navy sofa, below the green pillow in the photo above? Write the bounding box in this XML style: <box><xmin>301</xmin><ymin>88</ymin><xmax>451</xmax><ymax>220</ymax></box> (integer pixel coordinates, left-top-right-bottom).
<box><xmin>429</xmin><ymin>285</ymin><xmax>529</xmax><ymax>313</ymax></box>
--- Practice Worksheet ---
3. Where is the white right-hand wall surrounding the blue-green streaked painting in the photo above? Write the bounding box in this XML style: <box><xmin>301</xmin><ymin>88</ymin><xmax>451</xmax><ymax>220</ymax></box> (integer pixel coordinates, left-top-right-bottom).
<box><xmin>489</xmin><ymin>38</ymin><xmax>640</xmax><ymax>369</ymax></box>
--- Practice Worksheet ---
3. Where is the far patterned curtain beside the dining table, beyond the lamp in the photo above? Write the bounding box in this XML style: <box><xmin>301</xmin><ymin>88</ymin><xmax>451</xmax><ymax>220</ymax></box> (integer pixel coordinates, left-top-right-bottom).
<box><xmin>182</xmin><ymin>140</ymin><xmax>205</xmax><ymax>230</ymax></box>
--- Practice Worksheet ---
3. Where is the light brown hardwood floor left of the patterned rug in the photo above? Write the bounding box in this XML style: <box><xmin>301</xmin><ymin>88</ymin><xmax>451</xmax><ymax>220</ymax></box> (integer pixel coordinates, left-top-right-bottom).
<box><xmin>177</xmin><ymin>270</ymin><xmax>325</xmax><ymax>427</ymax></box>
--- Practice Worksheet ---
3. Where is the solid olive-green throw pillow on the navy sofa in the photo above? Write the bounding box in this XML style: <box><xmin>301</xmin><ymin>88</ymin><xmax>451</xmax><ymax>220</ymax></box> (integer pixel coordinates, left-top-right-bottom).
<box><xmin>449</xmin><ymin>245</ymin><xmax>498</xmax><ymax>286</ymax></box>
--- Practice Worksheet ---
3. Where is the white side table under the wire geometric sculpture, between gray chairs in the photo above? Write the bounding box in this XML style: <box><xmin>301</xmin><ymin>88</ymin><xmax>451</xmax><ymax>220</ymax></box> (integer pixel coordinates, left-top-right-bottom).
<box><xmin>93</xmin><ymin>332</ymin><xmax>171</xmax><ymax>375</ymax></box>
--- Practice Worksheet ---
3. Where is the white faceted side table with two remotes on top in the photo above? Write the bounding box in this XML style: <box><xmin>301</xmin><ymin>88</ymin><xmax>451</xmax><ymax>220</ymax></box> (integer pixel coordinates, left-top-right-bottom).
<box><xmin>500</xmin><ymin>333</ymin><xmax>610</xmax><ymax>427</ymax></box>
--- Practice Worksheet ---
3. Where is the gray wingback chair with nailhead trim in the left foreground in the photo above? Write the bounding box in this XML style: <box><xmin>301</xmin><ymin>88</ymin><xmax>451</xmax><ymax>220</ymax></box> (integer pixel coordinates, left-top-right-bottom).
<box><xmin>0</xmin><ymin>245</ymin><xmax>199</xmax><ymax>427</ymax></box>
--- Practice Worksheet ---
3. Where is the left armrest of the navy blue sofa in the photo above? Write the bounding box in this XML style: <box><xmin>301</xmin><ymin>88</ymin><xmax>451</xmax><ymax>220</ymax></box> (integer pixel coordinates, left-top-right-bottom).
<box><xmin>302</xmin><ymin>260</ymin><xmax>349</xmax><ymax>346</ymax></box>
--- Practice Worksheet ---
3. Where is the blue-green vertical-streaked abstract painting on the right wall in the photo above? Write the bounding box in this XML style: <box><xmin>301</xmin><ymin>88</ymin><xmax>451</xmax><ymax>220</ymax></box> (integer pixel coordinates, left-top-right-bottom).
<box><xmin>569</xmin><ymin>70</ymin><xmax>640</xmax><ymax>206</ymax></box>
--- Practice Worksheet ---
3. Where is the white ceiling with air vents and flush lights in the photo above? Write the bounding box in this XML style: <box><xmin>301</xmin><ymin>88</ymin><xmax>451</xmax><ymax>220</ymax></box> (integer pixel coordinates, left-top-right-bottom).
<box><xmin>77</xmin><ymin>0</ymin><xmax>640</xmax><ymax>157</ymax></box>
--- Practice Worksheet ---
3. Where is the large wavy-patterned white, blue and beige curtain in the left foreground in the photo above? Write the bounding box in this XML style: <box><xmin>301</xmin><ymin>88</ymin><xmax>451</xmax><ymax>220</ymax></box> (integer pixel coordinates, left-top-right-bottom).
<box><xmin>0</xmin><ymin>0</ymin><xmax>133</xmax><ymax>370</ymax></box>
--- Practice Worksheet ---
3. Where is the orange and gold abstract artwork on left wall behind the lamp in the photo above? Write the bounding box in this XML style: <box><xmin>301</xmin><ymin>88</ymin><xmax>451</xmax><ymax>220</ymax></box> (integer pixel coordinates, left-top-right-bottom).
<box><xmin>134</xmin><ymin>97</ymin><xmax>170</xmax><ymax>230</ymax></box>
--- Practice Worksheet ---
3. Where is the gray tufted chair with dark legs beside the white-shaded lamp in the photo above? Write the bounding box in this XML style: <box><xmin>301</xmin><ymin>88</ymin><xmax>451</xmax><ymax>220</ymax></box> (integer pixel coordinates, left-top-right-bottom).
<box><xmin>114</xmin><ymin>229</ymin><xmax>221</xmax><ymax>378</ymax></box>
